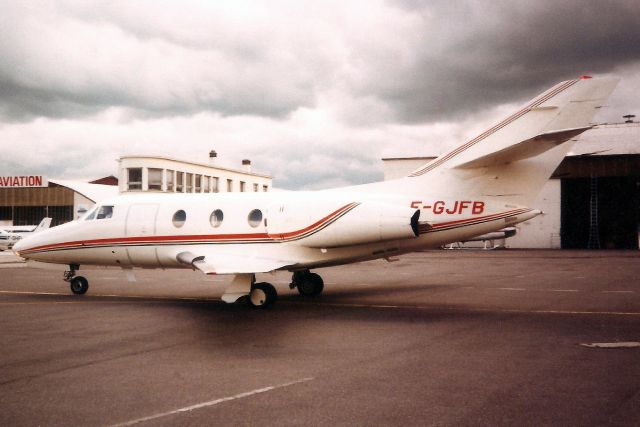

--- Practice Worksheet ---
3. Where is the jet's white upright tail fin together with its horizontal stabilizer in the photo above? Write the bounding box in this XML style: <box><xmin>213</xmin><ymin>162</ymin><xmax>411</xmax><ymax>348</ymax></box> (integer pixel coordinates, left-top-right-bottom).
<box><xmin>409</xmin><ymin>76</ymin><xmax>618</xmax><ymax>205</ymax></box>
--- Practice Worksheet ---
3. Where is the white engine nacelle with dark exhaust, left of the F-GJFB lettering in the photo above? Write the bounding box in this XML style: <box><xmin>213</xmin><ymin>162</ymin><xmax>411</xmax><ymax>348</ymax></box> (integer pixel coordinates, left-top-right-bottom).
<box><xmin>269</xmin><ymin>202</ymin><xmax>420</xmax><ymax>248</ymax></box>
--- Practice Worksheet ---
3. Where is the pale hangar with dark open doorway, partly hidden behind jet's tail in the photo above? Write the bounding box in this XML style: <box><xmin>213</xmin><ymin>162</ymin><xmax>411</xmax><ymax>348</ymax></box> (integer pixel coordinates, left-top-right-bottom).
<box><xmin>382</xmin><ymin>121</ymin><xmax>640</xmax><ymax>249</ymax></box>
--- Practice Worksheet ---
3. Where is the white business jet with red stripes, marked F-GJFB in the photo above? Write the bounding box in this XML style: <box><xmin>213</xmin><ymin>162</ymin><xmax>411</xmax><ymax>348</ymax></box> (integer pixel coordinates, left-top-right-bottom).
<box><xmin>14</xmin><ymin>76</ymin><xmax>617</xmax><ymax>308</ymax></box>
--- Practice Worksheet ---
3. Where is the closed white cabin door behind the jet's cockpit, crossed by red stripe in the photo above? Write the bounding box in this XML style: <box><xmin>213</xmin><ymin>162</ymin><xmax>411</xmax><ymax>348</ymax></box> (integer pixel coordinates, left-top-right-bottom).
<box><xmin>125</xmin><ymin>204</ymin><xmax>160</xmax><ymax>268</ymax></box>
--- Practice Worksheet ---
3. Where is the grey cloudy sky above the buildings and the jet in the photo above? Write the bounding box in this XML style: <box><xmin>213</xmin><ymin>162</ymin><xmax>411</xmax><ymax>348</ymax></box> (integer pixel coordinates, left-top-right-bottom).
<box><xmin>0</xmin><ymin>0</ymin><xmax>640</xmax><ymax>189</ymax></box>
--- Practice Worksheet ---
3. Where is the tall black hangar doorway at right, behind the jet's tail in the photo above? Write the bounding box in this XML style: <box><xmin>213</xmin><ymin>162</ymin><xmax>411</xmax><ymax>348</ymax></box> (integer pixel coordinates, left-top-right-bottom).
<box><xmin>560</xmin><ymin>176</ymin><xmax>640</xmax><ymax>249</ymax></box>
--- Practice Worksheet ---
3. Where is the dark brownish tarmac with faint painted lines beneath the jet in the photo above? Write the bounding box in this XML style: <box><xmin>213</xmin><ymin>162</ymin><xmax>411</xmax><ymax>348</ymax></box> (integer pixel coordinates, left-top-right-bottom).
<box><xmin>0</xmin><ymin>250</ymin><xmax>640</xmax><ymax>426</ymax></box>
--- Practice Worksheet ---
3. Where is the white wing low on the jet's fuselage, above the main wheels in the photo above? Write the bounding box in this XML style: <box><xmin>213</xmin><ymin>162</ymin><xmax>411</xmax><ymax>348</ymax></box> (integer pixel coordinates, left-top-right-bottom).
<box><xmin>176</xmin><ymin>251</ymin><xmax>295</xmax><ymax>274</ymax></box>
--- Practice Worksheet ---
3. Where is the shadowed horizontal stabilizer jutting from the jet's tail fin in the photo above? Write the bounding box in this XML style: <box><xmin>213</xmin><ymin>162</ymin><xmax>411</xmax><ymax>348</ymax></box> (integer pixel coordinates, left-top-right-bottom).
<box><xmin>456</xmin><ymin>126</ymin><xmax>592</xmax><ymax>169</ymax></box>
